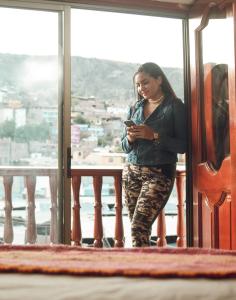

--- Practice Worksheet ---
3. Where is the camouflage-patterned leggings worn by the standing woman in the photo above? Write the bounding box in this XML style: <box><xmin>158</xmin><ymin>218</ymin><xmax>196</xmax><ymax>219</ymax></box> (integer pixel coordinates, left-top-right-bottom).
<box><xmin>122</xmin><ymin>165</ymin><xmax>175</xmax><ymax>247</ymax></box>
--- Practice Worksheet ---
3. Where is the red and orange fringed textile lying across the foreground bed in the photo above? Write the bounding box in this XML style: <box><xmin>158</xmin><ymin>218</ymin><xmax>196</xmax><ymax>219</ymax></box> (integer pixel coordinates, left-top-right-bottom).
<box><xmin>0</xmin><ymin>245</ymin><xmax>236</xmax><ymax>278</ymax></box>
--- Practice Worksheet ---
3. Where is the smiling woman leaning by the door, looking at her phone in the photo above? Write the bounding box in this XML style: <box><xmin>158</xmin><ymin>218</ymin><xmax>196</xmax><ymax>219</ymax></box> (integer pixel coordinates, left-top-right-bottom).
<box><xmin>122</xmin><ymin>62</ymin><xmax>186</xmax><ymax>247</ymax></box>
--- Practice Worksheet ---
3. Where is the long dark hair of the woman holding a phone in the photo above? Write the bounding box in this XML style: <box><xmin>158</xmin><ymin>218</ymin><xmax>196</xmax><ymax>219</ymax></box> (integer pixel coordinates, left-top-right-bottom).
<box><xmin>133</xmin><ymin>62</ymin><xmax>176</xmax><ymax>100</ymax></box>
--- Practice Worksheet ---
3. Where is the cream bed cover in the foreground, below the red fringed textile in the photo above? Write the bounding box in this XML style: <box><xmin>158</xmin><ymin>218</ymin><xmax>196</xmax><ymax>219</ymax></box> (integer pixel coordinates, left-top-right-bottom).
<box><xmin>0</xmin><ymin>274</ymin><xmax>236</xmax><ymax>300</ymax></box>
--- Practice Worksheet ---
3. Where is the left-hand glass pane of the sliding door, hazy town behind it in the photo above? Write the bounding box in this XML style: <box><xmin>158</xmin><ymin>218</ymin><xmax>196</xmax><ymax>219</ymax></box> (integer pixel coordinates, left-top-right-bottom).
<box><xmin>0</xmin><ymin>8</ymin><xmax>59</xmax><ymax>243</ymax></box>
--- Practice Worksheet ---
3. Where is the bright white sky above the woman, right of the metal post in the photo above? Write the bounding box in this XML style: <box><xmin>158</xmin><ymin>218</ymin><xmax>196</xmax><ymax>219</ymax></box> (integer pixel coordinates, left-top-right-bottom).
<box><xmin>72</xmin><ymin>10</ymin><xmax>182</xmax><ymax>66</ymax></box>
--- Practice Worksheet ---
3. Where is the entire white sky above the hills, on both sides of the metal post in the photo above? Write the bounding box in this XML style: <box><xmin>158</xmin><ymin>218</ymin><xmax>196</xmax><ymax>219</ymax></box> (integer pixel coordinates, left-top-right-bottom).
<box><xmin>0</xmin><ymin>8</ymin><xmax>183</xmax><ymax>67</ymax></box>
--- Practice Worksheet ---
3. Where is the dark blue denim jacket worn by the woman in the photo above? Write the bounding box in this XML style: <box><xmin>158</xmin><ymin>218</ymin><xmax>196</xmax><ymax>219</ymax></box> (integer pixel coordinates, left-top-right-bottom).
<box><xmin>121</xmin><ymin>96</ymin><xmax>187</xmax><ymax>166</ymax></box>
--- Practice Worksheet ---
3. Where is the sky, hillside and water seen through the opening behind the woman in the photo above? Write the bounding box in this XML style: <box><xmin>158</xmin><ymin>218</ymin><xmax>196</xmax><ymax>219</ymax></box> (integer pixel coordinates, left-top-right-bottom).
<box><xmin>71</xmin><ymin>9</ymin><xmax>184</xmax><ymax>245</ymax></box>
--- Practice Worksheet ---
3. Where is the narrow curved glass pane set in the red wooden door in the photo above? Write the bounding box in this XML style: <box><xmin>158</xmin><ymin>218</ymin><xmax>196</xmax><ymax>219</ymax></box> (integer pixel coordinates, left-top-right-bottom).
<box><xmin>202</xmin><ymin>19</ymin><xmax>232</xmax><ymax>170</ymax></box>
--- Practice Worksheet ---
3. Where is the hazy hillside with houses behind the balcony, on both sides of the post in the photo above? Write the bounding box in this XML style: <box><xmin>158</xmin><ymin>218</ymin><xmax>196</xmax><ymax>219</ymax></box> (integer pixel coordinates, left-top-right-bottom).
<box><xmin>0</xmin><ymin>54</ymin><xmax>183</xmax><ymax>166</ymax></box>
